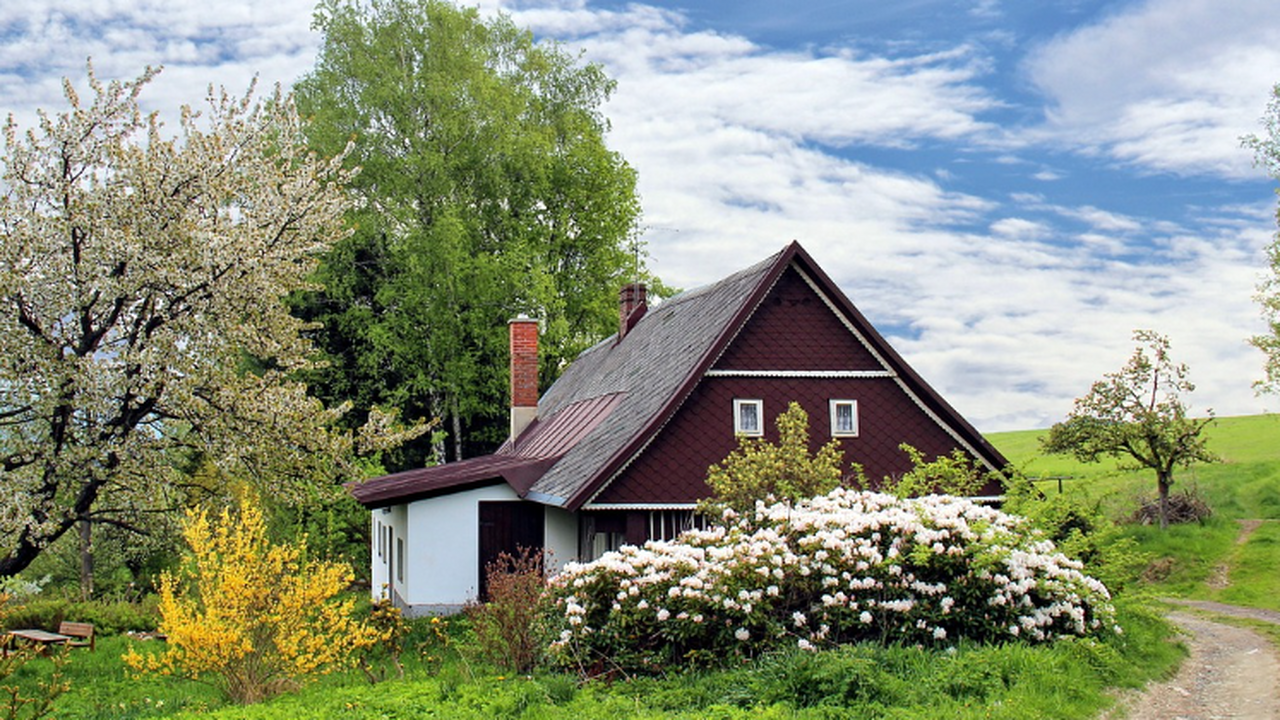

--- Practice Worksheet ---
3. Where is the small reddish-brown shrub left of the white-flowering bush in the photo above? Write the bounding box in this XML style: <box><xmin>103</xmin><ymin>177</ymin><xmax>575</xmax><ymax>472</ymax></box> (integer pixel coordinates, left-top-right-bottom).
<box><xmin>466</xmin><ymin>548</ymin><xmax>547</xmax><ymax>673</ymax></box>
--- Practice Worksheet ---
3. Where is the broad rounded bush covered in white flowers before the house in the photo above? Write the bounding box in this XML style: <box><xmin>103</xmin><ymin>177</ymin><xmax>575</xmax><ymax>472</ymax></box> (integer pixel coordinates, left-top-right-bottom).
<box><xmin>552</xmin><ymin>488</ymin><xmax>1114</xmax><ymax>670</ymax></box>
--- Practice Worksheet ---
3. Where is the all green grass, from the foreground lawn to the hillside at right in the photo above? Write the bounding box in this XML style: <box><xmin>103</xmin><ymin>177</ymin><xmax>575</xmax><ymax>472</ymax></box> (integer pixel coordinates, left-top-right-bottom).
<box><xmin>14</xmin><ymin>415</ymin><xmax>1280</xmax><ymax>720</ymax></box>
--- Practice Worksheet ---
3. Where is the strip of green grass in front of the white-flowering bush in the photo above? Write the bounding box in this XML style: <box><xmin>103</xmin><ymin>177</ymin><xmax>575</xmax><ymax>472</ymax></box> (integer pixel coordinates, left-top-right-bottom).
<box><xmin>142</xmin><ymin>599</ymin><xmax>1180</xmax><ymax>720</ymax></box>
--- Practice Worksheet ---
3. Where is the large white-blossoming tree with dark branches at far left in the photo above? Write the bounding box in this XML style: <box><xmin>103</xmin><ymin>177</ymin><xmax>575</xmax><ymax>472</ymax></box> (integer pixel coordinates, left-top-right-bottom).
<box><xmin>0</xmin><ymin>67</ymin><xmax>414</xmax><ymax>577</ymax></box>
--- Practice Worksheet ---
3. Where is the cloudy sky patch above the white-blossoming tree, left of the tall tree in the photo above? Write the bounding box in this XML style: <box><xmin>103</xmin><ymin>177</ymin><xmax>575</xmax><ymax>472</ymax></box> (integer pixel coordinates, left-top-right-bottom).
<box><xmin>0</xmin><ymin>0</ymin><xmax>319</xmax><ymax>127</ymax></box>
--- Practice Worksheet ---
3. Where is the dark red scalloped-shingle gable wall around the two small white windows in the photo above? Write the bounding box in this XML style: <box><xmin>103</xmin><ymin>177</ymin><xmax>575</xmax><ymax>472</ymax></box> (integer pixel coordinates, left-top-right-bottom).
<box><xmin>593</xmin><ymin>263</ymin><xmax>998</xmax><ymax>503</ymax></box>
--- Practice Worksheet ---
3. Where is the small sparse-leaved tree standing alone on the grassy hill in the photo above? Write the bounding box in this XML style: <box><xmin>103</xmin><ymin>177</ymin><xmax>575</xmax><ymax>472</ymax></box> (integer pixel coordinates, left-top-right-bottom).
<box><xmin>1041</xmin><ymin>331</ymin><xmax>1217</xmax><ymax>528</ymax></box>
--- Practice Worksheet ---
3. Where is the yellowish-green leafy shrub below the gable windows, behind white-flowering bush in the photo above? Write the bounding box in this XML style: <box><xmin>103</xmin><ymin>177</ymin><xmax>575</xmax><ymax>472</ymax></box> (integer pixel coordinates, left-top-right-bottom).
<box><xmin>700</xmin><ymin>402</ymin><xmax>861</xmax><ymax>516</ymax></box>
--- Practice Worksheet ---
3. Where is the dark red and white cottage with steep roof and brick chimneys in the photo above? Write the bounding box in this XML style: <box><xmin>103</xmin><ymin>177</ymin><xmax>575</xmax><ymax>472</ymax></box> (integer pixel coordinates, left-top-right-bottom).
<box><xmin>351</xmin><ymin>243</ymin><xmax>1006</xmax><ymax>614</ymax></box>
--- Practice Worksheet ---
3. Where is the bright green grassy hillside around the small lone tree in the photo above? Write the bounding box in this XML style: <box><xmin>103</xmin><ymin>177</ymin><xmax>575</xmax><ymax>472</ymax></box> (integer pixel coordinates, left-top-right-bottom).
<box><xmin>988</xmin><ymin>415</ymin><xmax>1280</xmax><ymax>610</ymax></box>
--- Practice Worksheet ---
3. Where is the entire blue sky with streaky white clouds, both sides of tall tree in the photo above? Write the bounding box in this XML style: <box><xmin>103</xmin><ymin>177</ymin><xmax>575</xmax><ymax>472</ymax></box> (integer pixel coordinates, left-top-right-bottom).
<box><xmin>0</xmin><ymin>0</ymin><xmax>1280</xmax><ymax>432</ymax></box>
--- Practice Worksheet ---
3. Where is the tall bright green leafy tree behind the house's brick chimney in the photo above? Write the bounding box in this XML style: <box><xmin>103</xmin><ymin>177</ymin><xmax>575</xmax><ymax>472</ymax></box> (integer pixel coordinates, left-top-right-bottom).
<box><xmin>296</xmin><ymin>0</ymin><xmax>646</xmax><ymax>470</ymax></box>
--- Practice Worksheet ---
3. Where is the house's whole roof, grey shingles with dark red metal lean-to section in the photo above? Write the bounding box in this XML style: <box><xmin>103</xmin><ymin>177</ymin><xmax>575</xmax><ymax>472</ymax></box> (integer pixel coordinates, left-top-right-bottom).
<box><xmin>351</xmin><ymin>242</ymin><xmax>1007</xmax><ymax>510</ymax></box>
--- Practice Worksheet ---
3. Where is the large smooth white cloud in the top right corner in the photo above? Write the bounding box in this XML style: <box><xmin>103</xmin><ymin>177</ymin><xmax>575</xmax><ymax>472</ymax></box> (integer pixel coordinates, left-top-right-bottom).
<box><xmin>1027</xmin><ymin>0</ymin><xmax>1280</xmax><ymax>177</ymax></box>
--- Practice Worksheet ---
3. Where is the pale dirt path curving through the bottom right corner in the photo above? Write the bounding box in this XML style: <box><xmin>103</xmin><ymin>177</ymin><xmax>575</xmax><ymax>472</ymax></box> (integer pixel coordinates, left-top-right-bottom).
<box><xmin>1110</xmin><ymin>601</ymin><xmax>1280</xmax><ymax>720</ymax></box>
